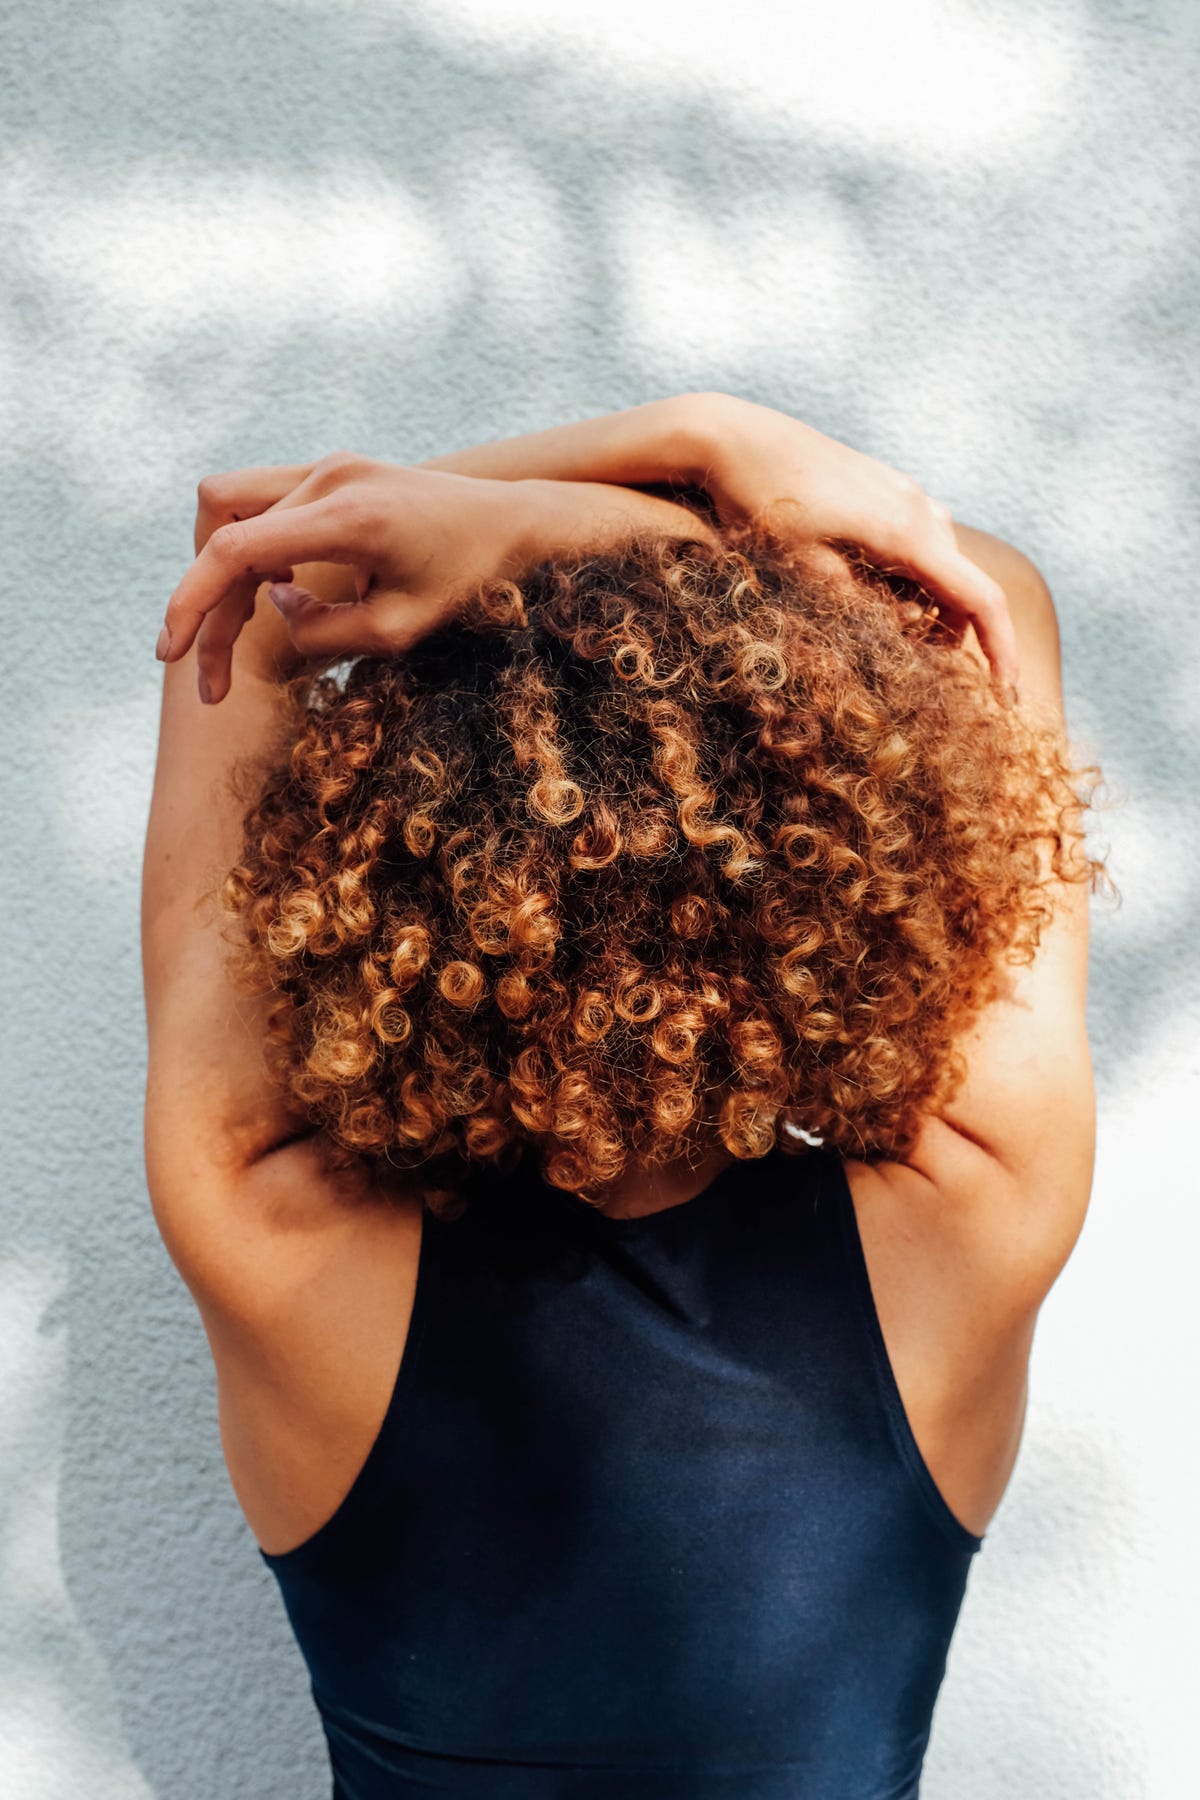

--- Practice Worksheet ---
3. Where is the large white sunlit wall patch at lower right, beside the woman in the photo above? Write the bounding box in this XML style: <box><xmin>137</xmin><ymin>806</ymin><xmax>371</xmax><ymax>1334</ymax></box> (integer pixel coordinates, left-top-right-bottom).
<box><xmin>1031</xmin><ymin>1044</ymin><xmax>1200</xmax><ymax>1800</ymax></box>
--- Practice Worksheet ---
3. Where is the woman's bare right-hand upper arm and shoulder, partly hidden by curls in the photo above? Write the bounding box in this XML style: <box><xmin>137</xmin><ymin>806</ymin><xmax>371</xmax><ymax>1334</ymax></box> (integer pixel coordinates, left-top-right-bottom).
<box><xmin>834</xmin><ymin>526</ymin><xmax>1096</xmax><ymax>1532</ymax></box>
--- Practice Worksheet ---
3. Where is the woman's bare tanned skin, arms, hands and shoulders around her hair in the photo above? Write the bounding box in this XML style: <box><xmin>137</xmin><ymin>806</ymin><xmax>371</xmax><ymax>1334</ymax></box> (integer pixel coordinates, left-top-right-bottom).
<box><xmin>144</xmin><ymin>396</ymin><xmax>1094</xmax><ymax>1553</ymax></box>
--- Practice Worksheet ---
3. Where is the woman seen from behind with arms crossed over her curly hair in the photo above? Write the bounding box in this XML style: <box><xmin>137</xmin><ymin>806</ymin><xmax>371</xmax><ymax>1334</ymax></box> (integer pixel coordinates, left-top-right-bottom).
<box><xmin>144</xmin><ymin>394</ymin><xmax>1096</xmax><ymax>1800</ymax></box>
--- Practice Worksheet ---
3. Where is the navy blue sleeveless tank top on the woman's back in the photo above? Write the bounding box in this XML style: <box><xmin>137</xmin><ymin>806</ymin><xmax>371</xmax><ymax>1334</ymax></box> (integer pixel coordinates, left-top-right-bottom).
<box><xmin>259</xmin><ymin>1150</ymin><xmax>982</xmax><ymax>1800</ymax></box>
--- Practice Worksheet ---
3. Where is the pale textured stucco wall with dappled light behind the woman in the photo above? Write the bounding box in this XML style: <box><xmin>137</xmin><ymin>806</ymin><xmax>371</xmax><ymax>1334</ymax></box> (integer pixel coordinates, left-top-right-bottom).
<box><xmin>0</xmin><ymin>0</ymin><xmax>1200</xmax><ymax>1800</ymax></box>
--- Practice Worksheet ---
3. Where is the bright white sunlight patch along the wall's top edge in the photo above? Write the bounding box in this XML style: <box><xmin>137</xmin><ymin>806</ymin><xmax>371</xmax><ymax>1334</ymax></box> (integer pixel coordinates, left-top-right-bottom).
<box><xmin>417</xmin><ymin>0</ymin><xmax>1076</xmax><ymax>167</ymax></box>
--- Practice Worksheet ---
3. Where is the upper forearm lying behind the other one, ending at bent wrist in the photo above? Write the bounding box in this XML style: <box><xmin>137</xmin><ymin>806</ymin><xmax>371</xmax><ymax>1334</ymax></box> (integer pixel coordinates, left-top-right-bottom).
<box><xmin>417</xmin><ymin>394</ymin><xmax>739</xmax><ymax>486</ymax></box>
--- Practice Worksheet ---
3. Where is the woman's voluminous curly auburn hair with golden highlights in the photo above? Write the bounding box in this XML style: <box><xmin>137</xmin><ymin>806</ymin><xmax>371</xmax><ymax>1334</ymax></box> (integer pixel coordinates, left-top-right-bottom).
<box><xmin>221</xmin><ymin>527</ymin><xmax>1101</xmax><ymax>1211</ymax></box>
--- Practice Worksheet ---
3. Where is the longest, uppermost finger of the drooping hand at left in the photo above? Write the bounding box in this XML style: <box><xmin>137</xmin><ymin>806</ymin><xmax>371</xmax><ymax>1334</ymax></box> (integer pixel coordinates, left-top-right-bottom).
<box><xmin>162</xmin><ymin>499</ymin><xmax>371</xmax><ymax>662</ymax></box>
